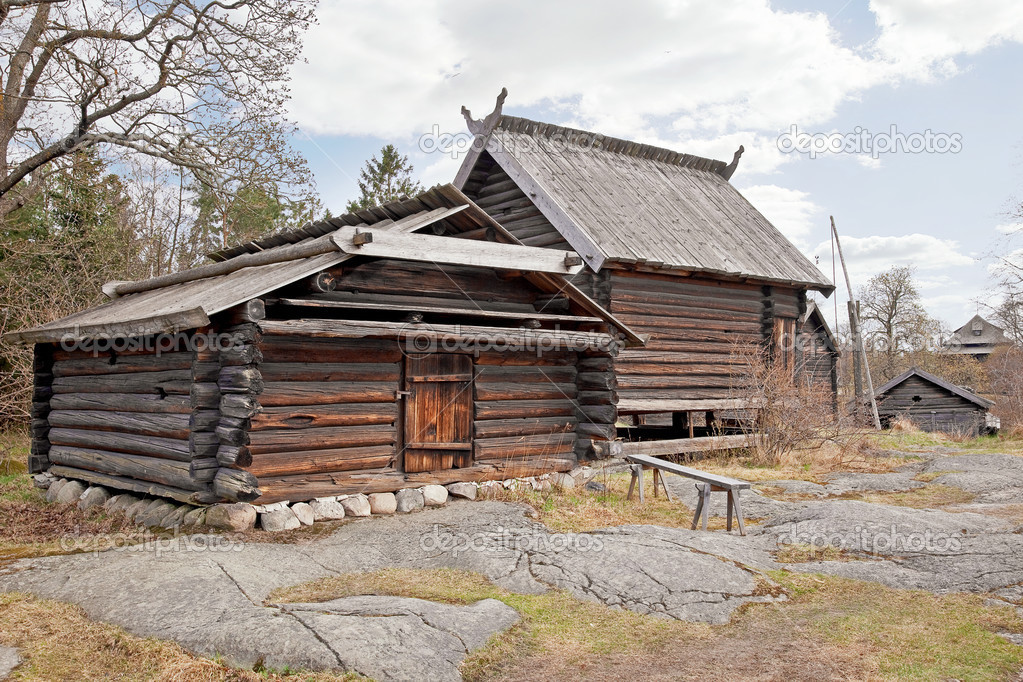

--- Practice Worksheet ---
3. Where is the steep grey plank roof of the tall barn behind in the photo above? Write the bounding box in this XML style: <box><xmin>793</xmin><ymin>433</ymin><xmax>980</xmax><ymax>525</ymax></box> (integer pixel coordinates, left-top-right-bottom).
<box><xmin>455</xmin><ymin>116</ymin><xmax>834</xmax><ymax>294</ymax></box>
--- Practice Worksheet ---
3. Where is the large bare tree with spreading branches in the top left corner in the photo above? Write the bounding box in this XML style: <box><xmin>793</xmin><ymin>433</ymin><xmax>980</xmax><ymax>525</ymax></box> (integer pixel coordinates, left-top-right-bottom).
<box><xmin>0</xmin><ymin>0</ymin><xmax>315</xmax><ymax>218</ymax></box>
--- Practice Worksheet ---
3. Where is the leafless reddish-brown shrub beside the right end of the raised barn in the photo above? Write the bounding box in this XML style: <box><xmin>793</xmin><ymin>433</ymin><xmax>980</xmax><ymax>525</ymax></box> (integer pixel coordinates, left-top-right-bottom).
<box><xmin>731</xmin><ymin>345</ymin><xmax>843</xmax><ymax>465</ymax></box>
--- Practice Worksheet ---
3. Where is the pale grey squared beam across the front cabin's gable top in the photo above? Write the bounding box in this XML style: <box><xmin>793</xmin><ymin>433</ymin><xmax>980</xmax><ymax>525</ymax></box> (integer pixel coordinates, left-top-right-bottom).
<box><xmin>330</xmin><ymin>227</ymin><xmax>582</xmax><ymax>275</ymax></box>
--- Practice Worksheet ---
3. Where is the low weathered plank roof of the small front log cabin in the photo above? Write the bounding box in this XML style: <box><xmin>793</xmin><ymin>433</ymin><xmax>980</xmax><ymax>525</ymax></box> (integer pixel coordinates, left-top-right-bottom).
<box><xmin>4</xmin><ymin>185</ymin><xmax>641</xmax><ymax>344</ymax></box>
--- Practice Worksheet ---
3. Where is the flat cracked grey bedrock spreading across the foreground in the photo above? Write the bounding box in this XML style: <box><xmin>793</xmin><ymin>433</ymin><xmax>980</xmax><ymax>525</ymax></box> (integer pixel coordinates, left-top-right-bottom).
<box><xmin>6</xmin><ymin>449</ymin><xmax>1023</xmax><ymax>680</ymax></box>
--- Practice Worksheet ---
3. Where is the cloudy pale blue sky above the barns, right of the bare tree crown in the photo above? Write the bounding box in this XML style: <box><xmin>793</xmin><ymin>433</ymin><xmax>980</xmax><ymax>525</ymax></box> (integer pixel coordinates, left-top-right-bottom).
<box><xmin>290</xmin><ymin>0</ymin><xmax>1023</xmax><ymax>327</ymax></box>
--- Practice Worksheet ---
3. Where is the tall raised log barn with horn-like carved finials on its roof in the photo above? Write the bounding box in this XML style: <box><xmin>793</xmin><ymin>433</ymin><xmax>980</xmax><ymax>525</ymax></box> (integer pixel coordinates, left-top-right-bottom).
<box><xmin>455</xmin><ymin>92</ymin><xmax>834</xmax><ymax>453</ymax></box>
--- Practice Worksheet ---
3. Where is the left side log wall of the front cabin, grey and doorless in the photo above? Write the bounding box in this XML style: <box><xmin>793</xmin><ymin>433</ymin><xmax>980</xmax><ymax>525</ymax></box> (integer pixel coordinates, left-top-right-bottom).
<box><xmin>46</xmin><ymin>335</ymin><xmax>219</xmax><ymax>502</ymax></box>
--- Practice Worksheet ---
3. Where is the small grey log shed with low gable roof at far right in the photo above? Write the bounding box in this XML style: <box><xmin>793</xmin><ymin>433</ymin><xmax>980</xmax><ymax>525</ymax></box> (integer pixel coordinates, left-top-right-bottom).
<box><xmin>875</xmin><ymin>367</ymin><xmax>998</xmax><ymax>436</ymax></box>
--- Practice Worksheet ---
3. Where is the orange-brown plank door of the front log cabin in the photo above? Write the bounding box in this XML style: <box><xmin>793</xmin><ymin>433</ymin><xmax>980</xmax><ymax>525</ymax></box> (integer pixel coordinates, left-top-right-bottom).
<box><xmin>404</xmin><ymin>353</ymin><xmax>473</xmax><ymax>473</ymax></box>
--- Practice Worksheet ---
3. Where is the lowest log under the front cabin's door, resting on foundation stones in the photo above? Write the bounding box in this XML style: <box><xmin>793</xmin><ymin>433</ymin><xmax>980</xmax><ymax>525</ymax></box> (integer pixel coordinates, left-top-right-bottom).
<box><xmin>250</xmin><ymin>456</ymin><xmax>577</xmax><ymax>504</ymax></box>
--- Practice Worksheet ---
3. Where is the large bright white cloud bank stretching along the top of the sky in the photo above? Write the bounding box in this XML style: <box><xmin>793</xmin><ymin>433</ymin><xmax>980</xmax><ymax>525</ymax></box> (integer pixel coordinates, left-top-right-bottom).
<box><xmin>292</xmin><ymin>0</ymin><xmax>1023</xmax><ymax>152</ymax></box>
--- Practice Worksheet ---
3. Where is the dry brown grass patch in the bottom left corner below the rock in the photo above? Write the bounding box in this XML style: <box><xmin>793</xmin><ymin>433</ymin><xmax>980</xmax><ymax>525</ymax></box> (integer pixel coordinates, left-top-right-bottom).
<box><xmin>0</xmin><ymin>594</ymin><xmax>356</xmax><ymax>682</ymax></box>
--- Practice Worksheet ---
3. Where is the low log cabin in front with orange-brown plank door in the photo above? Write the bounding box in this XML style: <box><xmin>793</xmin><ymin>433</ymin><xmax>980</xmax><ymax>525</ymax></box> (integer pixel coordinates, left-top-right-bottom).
<box><xmin>11</xmin><ymin>185</ymin><xmax>640</xmax><ymax>503</ymax></box>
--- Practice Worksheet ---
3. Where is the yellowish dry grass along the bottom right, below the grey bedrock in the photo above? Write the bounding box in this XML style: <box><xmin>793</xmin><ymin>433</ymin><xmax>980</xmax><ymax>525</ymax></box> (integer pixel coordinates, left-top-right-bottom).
<box><xmin>271</xmin><ymin>569</ymin><xmax>1023</xmax><ymax>682</ymax></box>
